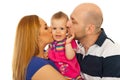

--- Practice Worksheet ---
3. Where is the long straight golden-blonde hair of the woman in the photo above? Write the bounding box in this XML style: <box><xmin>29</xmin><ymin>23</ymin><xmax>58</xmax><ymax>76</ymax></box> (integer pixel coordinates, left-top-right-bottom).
<box><xmin>12</xmin><ymin>15</ymin><xmax>41</xmax><ymax>80</ymax></box>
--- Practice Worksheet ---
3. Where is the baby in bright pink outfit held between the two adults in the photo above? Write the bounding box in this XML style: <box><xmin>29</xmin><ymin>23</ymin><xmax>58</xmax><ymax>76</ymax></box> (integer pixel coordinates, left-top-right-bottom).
<box><xmin>48</xmin><ymin>11</ymin><xmax>83</xmax><ymax>80</ymax></box>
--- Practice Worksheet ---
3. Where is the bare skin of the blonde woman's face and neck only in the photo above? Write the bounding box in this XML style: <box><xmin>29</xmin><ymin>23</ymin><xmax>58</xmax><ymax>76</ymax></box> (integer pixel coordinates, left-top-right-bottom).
<box><xmin>38</xmin><ymin>18</ymin><xmax>53</xmax><ymax>59</ymax></box>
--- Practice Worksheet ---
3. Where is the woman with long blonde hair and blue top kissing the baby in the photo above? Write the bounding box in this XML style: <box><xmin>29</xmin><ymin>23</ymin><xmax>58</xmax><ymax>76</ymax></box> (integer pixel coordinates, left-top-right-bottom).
<box><xmin>12</xmin><ymin>15</ymin><xmax>65</xmax><ymax>80</ymax></box>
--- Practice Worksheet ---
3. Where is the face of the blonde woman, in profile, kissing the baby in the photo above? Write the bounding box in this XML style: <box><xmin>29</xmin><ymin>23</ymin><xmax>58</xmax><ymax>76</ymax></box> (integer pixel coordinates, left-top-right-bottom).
<box><xmin>40</xmin><ymin>18</ymin><xmax>53</xmax><ymax>44</ymax></box>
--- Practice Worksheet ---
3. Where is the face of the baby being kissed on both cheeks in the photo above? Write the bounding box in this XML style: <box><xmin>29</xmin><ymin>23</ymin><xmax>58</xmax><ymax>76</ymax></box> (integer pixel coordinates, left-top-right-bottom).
<box><xmin>51</xmin><ymin>19</ymin><xmax>67</xmax><ymax>41</ymax></box>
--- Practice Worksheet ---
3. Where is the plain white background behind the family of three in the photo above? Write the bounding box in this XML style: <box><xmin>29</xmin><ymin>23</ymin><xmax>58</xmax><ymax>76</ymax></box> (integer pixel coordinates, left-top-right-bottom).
<box><xmin>0</xmin><ymin>0</ymin><xmax>120</xmax><ymax>80</ymax></box>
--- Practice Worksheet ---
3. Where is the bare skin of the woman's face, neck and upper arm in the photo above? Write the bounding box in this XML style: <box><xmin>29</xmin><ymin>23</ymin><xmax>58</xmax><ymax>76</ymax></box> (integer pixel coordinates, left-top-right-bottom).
<box><xmin>32</xmin><ymin>17</ymin><xmax>66</xmax><ymax>80</ymax></box>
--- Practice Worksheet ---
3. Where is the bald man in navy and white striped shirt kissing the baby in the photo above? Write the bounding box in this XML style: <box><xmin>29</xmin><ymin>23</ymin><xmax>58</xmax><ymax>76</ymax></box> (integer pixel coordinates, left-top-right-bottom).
<box><xmin>67</xmin><ymin>3</ymin><xmax>120</xmax><ymax>80</ymax></box>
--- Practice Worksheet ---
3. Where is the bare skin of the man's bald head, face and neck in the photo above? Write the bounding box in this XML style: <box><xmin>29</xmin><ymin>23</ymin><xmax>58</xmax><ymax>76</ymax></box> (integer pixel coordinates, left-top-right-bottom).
<box><xmin>67</xmin><ymin>3</ymin><xmax>103</xmax><ymax>53</ymax></box>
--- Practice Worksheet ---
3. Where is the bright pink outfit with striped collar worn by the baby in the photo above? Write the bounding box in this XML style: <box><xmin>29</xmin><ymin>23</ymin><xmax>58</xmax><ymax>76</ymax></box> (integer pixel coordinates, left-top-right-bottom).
<box><xmin>48</xmin><ymin>40</ymin><xmax>80</xmax><ymax>78</ymax></box>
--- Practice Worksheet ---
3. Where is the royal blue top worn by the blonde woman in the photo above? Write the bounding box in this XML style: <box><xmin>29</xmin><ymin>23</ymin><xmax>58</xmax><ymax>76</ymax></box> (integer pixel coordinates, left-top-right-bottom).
<box><xmin>26</xmin><ymin>56</ymin><xmax>56</xmax><ymax>80</ymax></box>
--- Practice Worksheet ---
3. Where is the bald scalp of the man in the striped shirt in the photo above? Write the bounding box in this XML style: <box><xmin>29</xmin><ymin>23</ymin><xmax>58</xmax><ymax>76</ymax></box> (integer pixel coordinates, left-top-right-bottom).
<box><xmin>72</xmin><ymin>3</ymin><xmax>103</xmax><ymax>32</ymax></box>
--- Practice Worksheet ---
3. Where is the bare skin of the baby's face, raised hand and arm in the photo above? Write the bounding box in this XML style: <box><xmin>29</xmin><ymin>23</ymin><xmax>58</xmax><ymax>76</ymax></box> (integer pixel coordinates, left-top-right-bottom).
<box><xmin>51</xmin><ymin>18</ymin><xmax>75</xmax><ymax>60</ymax></box>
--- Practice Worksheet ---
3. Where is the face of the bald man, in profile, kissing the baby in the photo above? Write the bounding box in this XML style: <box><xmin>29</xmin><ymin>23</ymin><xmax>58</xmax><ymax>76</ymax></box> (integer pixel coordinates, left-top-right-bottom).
<box><xmin>67</xmin><ymin>11</ymin><xmax>86</xmax><ymax>40</ymax></box>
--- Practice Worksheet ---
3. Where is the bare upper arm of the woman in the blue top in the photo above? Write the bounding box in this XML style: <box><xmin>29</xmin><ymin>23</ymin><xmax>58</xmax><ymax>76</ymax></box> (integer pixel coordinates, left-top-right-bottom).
<box><xmin>32</xmin><ymin>65</ymin><xmax>66</xmax><ymax>80</ymax></box>
